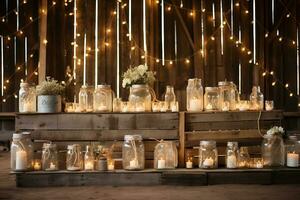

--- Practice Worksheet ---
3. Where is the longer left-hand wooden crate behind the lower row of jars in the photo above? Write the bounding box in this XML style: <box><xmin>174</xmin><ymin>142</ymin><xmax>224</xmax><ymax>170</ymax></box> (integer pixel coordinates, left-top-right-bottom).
<box><xmin>16</xmin><ymin>113</ymin><xmax>179</xmax><ymax>169</ymax></box>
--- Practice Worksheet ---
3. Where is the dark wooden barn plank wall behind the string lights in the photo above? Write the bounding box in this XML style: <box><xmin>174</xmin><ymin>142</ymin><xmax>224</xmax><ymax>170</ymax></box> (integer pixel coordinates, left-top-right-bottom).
<box><xmin>0</xmin><ymin>0</ymin><xmax>300</xmax><ymax>111</ymax></box>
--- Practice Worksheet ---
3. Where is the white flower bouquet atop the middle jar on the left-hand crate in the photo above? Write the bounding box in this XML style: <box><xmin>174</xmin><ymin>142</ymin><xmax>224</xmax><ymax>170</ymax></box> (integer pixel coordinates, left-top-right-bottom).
<box><xmin>122</xmin><ymin>65</ymin><xmax>156</xmax><ymax>88</ymax></box>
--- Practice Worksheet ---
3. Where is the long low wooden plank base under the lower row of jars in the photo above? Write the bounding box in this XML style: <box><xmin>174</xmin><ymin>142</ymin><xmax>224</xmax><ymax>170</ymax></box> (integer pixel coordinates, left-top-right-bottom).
<box><xmin>12</xmin><ymin>168</ymin><xmax>300</xmax><ymax>187</ymax></box>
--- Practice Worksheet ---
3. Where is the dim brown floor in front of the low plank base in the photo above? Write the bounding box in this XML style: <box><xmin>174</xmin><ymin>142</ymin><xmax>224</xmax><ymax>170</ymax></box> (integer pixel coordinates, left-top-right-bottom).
<box><xmin>0</xmin><ymin>152</ymin><xmax>300</xmax><ymax>200</ymax></box>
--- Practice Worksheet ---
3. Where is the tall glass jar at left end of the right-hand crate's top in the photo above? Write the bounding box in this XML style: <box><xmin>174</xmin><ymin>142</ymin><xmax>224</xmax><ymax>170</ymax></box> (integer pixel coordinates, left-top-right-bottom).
<box><xmin>186</xmin><ymin>78</ymin><xmax>203</xmax><ymax>112</ymax></box>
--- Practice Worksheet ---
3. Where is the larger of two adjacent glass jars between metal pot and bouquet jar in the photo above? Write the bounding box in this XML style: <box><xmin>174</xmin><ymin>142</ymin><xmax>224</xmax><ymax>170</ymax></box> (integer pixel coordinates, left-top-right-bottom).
<box><xmin>94</xmin><ymin>85</ymin><xmax>114</xmax><ymax>112</ymax></box>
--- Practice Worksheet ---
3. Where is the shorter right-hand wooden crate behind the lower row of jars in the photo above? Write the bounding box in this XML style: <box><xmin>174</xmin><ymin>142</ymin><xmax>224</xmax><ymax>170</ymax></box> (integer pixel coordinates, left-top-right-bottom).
<box><xmin>180</xmin><ymin>110</ymin><xmax>283</xmax><ymax>165</ymax></box>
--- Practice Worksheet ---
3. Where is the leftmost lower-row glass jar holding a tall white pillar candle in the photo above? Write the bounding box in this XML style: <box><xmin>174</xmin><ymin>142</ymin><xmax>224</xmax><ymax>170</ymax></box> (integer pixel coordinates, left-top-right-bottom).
<box><xmin>10</xmin><ymin>133</ymin><xmax>32</xmax><ymax>171</ymax></box>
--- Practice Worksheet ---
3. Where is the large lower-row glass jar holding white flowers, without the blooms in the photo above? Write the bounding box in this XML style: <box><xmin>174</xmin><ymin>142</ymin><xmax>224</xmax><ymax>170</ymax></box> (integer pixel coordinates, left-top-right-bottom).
<box><xmin>262</xmin><ymin>134</ymin><xmax>285</xmax><ymax>167</ymax></box>
